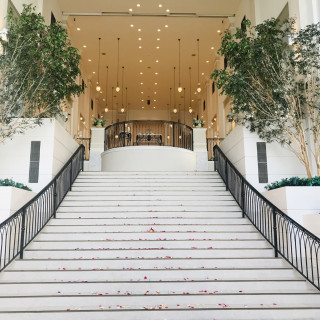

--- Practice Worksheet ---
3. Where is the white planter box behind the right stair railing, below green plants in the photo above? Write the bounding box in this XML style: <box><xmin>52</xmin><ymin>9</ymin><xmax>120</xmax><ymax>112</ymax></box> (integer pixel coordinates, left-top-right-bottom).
<box><xmin>263</xmin><ymin>187</ymin><xmax>320</xmax><ymax>237</ymax></box>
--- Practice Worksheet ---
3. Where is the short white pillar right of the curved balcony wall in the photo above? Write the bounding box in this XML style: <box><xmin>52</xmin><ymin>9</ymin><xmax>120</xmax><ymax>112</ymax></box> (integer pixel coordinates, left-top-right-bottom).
<box><xmin>193</xmin><ymin>128</ymin><xmax>208</xmax><ymax>171</ymax></box>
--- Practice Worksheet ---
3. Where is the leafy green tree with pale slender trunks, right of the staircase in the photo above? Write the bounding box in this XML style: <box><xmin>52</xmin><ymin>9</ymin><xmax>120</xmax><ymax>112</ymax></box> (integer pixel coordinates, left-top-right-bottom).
<box><xmin>211</xmin><ymin>19</ymin><xmax>320</xmax><ymax>177</ymax></box>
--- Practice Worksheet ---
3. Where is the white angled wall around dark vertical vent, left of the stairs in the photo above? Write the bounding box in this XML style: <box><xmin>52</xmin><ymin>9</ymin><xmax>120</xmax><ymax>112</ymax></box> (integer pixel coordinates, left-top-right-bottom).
<box><xmin>0</xmin><ymin>119</ymin><xmax>79</xmax><ymax>192</ymax></box>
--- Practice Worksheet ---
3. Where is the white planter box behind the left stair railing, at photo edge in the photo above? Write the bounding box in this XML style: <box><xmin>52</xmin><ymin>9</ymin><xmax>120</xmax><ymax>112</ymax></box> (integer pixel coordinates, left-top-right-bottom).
<box><xmin>0</xmin><ymin>187</ymin><xmax>36</xmax><ymax>223</ymax></box>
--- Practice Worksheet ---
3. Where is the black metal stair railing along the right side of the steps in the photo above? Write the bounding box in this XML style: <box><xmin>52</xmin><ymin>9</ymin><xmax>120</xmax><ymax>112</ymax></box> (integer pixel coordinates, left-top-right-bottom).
<box><xmin>214</xmin><ymin>146</ymin><xmax>320</xmax><ymax>290</ymax></box>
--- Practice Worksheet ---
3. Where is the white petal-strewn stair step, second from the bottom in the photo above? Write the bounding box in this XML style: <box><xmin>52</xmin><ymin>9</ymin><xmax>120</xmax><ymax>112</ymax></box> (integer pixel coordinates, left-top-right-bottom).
<box><xmin>0</xmin><ymin>294</ymin><xmax>320</xmax><ymax>312</ymax></box>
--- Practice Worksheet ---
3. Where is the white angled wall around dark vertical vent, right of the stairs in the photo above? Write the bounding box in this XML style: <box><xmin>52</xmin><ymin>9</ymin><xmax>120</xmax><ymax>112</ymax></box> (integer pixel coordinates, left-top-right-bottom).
<box><xmin>220</xmin><ymin>126</ymin><xmax>306</xmax><ymax>192</ymax></box>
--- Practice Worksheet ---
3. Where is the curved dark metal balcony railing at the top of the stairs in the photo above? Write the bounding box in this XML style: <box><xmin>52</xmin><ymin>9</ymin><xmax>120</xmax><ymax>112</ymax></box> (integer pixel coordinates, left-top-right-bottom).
<box><xmin>105</xmin><ymin>120</ymin><xmax>193</xmax><ymax>150</ymax></box>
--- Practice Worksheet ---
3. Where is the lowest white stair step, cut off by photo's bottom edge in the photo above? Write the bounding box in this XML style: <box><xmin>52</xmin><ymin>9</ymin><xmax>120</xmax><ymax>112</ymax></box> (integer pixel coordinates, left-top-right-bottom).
<box><xmin>0</xmin><ymin>310</ymin><xmax>320</xmax><ymax>320</ymax></box>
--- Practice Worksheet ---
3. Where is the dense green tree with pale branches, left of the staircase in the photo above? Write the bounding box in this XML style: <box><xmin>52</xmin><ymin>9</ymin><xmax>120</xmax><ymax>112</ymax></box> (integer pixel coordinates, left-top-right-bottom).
<box><xmin>0</xmin><ymin>6</ymin><xmax>82</xmax><ymax>142</ymax></box>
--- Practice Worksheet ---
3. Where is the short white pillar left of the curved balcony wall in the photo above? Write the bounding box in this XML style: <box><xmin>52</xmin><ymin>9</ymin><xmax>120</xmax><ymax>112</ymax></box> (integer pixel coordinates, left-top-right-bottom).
<box><xmin>89</xmin><ymin>128</ymin><xmax>105</xmax><ymax>171</ymax></box>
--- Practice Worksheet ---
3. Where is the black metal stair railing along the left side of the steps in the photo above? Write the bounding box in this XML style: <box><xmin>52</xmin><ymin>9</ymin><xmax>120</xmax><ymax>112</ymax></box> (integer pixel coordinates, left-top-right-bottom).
<box><xmin>0</xmin><ymin>145</ymin><xmax>84</xmax><ymax>271</ymax></box>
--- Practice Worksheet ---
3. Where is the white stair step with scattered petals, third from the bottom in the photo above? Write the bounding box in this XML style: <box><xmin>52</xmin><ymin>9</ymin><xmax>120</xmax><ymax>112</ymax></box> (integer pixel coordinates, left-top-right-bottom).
<box><xmin>0</xmin><ymin>280</ymin><xmax>317</xmax><ymax>297</ymax></box>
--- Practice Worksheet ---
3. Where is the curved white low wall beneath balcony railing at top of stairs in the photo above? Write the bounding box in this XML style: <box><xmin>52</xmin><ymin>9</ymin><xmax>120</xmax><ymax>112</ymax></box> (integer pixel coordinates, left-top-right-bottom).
<box><xmin>101</xmin><ymin>146</ymin><xmax>196</xmax><ymax>171</ymax></box>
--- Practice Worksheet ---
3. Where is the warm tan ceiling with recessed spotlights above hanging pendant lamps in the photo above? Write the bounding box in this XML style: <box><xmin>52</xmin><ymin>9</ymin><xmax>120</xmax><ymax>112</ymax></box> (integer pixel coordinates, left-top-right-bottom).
<box><xmin>59</xmin><ymin>0</ymin><xmax>239</xmax><ymax>110</ymax></box>
